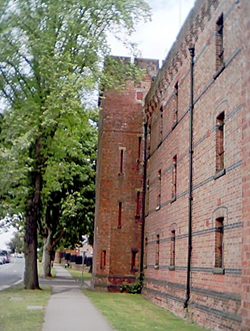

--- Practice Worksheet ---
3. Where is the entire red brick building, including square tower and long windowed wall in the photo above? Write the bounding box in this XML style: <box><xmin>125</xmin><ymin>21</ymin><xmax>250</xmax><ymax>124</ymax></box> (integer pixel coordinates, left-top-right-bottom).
<box><xmin>93</xmin><ymin>0</ymin><xmax>250</xmax><ymax>331</ymax></box>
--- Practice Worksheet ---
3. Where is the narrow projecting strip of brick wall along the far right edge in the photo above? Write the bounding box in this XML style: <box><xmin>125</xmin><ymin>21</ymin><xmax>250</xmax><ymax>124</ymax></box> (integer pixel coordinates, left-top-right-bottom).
<box><xmin>241</xmin><ymin>0</ymin><xmax>250</xmax><ymax>331</ymax></box>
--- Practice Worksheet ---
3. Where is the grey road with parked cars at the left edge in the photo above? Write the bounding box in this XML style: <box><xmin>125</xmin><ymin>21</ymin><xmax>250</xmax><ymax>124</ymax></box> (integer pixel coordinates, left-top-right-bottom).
<box><xmin>0</xmin><ymin>257</ymin><xmax>24</xmax><ymax>290</ymax></box>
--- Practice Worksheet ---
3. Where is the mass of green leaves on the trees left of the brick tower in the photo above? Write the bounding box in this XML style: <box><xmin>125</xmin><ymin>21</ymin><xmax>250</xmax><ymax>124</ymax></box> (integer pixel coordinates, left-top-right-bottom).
<box><xmin>0</xmin><ymin>0</ymin><xmax>150</xmax><ymax>286</ymax></box>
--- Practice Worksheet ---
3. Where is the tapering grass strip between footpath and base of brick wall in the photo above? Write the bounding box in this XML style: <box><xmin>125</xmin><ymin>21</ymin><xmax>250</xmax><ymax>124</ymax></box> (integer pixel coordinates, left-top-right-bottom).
<box><xmin>83</xmin><ymin>289</ymin><xmax>206</xmax><ymax>331</ymax></box>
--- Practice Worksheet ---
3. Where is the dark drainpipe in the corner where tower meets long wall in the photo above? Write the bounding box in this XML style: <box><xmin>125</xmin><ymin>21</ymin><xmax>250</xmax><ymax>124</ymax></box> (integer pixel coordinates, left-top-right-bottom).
<box><xmin>140</xmin><ymin>122</ymin><xmax>148</xmax><ymax>281</ymax></box>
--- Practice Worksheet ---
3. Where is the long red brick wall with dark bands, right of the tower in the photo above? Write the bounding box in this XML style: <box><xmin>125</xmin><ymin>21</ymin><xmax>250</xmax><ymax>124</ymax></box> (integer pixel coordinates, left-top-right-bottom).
<box><xmin>144</xmin><ymin>1</ymin><xmax>243</xmax><ymax>330</ymax></box>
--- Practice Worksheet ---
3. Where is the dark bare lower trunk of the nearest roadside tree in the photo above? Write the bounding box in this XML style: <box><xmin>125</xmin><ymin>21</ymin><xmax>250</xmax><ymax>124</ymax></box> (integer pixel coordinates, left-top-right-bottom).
<box><xmin>24</xmin><ymin>208</ymin><xmax>40</xmax><ymax>290</ymax></box>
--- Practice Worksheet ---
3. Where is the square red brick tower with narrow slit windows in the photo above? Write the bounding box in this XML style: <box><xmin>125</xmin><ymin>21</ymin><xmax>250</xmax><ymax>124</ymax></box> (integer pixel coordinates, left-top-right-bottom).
<box><xmin>92</xmin><ymin>58</ymin><xmax>159</xmax><ymax>291</ymax></box>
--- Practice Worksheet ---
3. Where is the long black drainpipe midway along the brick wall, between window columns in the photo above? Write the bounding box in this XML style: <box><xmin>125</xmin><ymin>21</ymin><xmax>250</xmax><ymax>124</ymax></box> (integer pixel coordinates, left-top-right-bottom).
<box><xmin>184</xmin><ymin>45</ymin><xmax>195</xmax><ymax>308</ymax></box>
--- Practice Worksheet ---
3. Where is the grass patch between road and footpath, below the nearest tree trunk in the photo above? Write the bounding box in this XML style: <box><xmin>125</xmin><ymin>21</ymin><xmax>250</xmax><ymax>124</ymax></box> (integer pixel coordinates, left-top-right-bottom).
<box><xmin>0</xmin><ymin>285</ymin><xmax>50</xmax><ymax>331</ymax></box>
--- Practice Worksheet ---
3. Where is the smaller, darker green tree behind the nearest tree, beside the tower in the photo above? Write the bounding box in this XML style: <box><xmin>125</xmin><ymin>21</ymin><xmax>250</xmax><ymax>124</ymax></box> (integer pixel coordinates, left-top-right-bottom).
<box><xmin>39</xmin><ymin>111</ymin><xmax>97</xmax><ymax>277</ymax></box>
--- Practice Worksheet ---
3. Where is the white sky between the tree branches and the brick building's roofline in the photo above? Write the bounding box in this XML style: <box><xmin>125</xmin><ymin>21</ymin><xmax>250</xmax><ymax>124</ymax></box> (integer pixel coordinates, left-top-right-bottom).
<box><xmin>110</xmin><ymin>0</ymin><xmax>195</xmax><ymax>60</ymax></box>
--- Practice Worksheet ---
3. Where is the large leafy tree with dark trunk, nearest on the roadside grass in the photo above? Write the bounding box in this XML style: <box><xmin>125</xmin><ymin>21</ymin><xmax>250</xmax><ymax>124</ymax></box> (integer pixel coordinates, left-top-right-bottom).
<box><xmin>0</xmin><ymin>0</ymin><xmax>149</xmax><ymax>289</ymax></box>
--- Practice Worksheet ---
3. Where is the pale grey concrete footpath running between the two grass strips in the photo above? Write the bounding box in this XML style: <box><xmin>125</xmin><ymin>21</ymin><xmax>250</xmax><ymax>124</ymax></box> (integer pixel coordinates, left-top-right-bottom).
<box><xmin>40</xmin><ymin>265</ymin><xmax>114</xmax><ymax>331</ymax></box>
